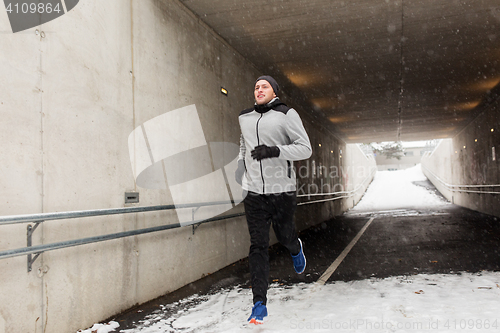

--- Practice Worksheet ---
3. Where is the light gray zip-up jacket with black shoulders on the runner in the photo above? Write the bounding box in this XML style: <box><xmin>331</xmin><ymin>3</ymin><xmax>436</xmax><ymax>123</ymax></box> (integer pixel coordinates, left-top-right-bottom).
<box><xmin>238</xmin><ymin>98</ymin><xmax>312</xmax><ymax>194</ymax></box>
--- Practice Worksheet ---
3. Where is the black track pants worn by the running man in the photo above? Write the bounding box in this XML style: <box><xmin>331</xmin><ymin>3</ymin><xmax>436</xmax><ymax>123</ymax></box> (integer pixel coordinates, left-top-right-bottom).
<box><xmin>244</xmin><ymin>192</ymin><xmax>300</xmax><ymax>304</ymax></box>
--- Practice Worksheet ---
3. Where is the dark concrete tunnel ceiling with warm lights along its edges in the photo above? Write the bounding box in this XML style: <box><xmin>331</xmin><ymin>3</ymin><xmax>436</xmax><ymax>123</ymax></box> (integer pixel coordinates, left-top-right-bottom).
<box><xmin>181</xmin><ymin>0</ymin><xmax>500</xmax><ymax>142</ymax></box>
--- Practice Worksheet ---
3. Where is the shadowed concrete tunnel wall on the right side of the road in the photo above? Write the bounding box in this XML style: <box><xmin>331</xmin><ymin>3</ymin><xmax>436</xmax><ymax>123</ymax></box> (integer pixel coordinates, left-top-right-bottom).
<box><xmin>422</xmin><ymin>98</ymin><xmax>500</xmax><ymax>217</ymax></box>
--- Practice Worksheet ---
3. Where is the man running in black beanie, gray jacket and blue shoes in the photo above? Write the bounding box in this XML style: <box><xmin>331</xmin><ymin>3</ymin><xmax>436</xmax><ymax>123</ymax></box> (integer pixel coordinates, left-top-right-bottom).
<box><xmin>236</xmin><ymin>75</ymin><xmax>312</xmax><ymax>324</ymax></box>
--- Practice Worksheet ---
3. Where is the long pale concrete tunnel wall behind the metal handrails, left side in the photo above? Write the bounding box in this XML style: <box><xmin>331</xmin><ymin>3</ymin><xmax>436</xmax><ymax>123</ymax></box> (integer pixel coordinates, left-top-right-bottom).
<box><xmin>0</xmin><ymin>0</ymin><xmax>374</xmax><ymax>333</ymax></box>
